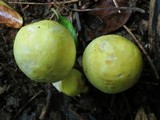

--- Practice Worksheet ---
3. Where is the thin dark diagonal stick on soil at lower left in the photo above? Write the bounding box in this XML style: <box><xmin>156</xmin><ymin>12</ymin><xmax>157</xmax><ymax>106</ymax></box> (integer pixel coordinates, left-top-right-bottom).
<box><xmin>14</xmin><ymin>90</ymin><xmax>43</xmax><ymax>120</ymax></box>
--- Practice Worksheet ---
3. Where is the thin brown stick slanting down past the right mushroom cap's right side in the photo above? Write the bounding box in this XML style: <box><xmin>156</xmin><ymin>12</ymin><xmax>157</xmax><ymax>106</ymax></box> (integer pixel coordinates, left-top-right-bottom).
<box><xmin>123</xmin><ymin>25</ymin><xmax>160</xmax><ymax>79</ymax></box>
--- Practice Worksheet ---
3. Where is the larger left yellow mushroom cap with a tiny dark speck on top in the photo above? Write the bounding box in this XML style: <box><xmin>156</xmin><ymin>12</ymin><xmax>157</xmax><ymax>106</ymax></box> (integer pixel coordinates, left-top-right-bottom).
<box><xmin>14</xmin><ymin>20</ymin><xmax>76</xmax><ymax>82</ymax></box>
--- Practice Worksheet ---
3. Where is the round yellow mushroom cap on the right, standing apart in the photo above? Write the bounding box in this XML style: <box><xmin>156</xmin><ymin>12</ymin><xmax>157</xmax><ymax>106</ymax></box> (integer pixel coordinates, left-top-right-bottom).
<box><xmin>82</xmin><ymin>35</ymin><xmax>143</xmax><ymax>93</ymax></box>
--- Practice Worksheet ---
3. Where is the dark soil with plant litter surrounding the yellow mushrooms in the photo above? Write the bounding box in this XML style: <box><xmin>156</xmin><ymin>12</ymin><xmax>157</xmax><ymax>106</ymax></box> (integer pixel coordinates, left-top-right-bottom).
<box><xmin>0</xmin><ymin>0</ymin><xmax>160</xmax><ymax>120</ymax></box>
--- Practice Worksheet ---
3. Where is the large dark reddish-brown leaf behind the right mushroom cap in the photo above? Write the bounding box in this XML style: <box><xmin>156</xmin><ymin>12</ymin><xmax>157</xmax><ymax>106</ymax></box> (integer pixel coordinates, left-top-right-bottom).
<box><xmin>90</xmin><ymin>0</ymin><xmax>132</xmax><ymax>34</ymax></box>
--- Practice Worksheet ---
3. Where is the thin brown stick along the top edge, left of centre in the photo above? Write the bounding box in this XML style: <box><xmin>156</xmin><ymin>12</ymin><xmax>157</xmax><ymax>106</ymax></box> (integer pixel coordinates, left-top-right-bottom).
<box><xmin>8</xmin><ymin>0</ymin><xmax>79</xmax><ymax>5</ymax></box>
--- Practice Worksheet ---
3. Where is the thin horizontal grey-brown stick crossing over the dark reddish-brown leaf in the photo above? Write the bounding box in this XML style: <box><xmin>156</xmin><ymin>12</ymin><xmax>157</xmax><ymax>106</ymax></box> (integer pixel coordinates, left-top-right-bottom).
<box><xmin>72</xmin><ymin>7</ymin><xmax>145</xmax><ymax>13</ymax></box>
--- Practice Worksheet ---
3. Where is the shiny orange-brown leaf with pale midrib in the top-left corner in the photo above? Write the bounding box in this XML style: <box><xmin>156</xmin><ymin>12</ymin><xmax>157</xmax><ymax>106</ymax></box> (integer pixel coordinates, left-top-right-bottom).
<box><xmin>0</xmin><ymin>1</ymin><xmax>23</xmax><ymax>28</ymax></box>
